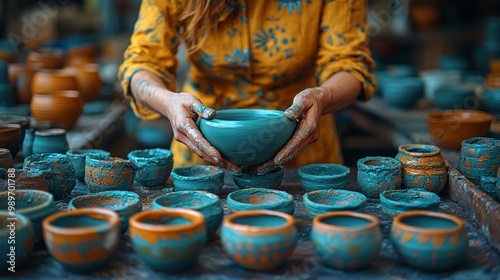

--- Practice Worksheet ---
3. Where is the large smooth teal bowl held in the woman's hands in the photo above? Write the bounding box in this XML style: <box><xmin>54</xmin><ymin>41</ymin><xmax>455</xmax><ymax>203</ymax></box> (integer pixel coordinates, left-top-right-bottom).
<box><xmin>200</xmin><ymin>109</ymin><xmax>297</xmax><ymax>166</ymax></box>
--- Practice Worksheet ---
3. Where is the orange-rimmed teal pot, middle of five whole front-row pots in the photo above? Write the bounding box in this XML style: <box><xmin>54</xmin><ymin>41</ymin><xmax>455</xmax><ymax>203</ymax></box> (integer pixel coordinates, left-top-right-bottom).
<box><xmin>221</xmin><ymin>210</ymin><xmax>297</xmax><ymax>270</ymax></box>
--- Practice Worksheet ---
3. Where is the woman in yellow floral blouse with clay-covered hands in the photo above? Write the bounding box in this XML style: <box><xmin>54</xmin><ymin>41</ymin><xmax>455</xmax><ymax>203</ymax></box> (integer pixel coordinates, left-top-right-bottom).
<box><xmin>119</xmin><ymin>0</ymin><xmax>375</xmax><ymax>173</ymax></box>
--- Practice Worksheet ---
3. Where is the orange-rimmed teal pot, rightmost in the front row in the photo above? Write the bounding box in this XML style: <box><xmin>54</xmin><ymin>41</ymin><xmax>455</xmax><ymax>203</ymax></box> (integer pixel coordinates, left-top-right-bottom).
<box><xmin>390</xmin><ymin>211</ymin><xmax>468</xmax><ymax>271</ymax></box>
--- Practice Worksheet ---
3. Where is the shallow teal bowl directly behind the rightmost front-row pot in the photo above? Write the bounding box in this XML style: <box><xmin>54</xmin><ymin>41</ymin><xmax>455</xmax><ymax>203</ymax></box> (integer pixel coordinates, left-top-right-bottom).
<box><xmin>380</xmin><ymin>189</ymin><xmax>441</xmax><ymax>217</ymax></box>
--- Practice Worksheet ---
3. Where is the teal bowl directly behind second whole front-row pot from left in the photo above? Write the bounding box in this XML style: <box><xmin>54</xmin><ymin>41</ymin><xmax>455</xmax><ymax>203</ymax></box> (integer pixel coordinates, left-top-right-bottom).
<box><xmin>153</xmin><ymin>191</ymin><xmax>224</xmax><ymax>241</ymax></box>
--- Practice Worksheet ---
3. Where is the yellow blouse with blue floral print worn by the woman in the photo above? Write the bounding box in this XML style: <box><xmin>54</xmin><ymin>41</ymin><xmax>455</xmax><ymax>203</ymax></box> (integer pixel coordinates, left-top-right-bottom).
<box><xmin>119</xmin><ymin>0</ymin><xmax>375</xmax><ymax>168</ymax></box>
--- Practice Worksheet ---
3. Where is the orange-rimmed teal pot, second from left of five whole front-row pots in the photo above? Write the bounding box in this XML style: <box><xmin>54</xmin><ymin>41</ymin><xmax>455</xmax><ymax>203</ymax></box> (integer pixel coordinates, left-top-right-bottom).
<box><xmin>129</xmin><ymin>208</ymin><xmax>206</xmax><ymax>272</ymax></box>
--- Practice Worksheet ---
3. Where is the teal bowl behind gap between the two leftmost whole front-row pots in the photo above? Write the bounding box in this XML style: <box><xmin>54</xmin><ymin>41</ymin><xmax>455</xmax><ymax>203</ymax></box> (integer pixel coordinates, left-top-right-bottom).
<box><xmin>68</xmin><ymin>191</ymin><xmax>142</xmax><ymax>233</ymax></box>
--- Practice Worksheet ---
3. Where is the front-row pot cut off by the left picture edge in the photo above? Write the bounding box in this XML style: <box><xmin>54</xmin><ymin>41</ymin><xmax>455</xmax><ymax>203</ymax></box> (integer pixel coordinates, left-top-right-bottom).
<box><xmin>0</xmin><ymin>213</ymin><xmax>34</xmax><ymax>273</ymax></box>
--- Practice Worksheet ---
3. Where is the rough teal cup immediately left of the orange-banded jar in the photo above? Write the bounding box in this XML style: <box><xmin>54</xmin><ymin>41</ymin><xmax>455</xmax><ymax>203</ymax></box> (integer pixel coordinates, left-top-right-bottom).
<box><xmin>357</xmin><ymin>157</ymin><xmax>401</xmax><ymax>198</ymax></box>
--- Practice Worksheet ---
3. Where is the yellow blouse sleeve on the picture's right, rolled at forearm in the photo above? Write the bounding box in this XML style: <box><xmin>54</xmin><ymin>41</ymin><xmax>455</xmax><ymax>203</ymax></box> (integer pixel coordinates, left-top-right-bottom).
<box><xmin>316</xmin><ymin>0</ymin><xmax>376</xmax><ymax>100</ymax></box>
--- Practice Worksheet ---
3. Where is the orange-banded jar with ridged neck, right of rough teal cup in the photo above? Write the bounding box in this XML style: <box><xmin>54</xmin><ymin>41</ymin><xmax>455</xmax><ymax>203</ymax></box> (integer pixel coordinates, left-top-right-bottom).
<box><xmin>396</xmin><ymin>144</ymin><xmax>448</xmax><ymax>193</ymax></box>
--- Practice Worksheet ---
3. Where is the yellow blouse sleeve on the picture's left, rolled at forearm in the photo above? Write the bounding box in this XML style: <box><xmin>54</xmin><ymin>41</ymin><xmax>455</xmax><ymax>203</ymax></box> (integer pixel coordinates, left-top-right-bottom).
<box><xmin>118</xmin><ymin>0</ymin><xmax>179</xmax><ymax>119</ymax></box>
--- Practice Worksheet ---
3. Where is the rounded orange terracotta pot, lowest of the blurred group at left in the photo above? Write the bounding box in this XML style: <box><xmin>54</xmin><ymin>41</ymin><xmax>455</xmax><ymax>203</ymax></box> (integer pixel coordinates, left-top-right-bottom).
<box><xmin>30</xmin><ymin>90</ymin><xmax>83</xmax><ymax>129</ymax></box>
